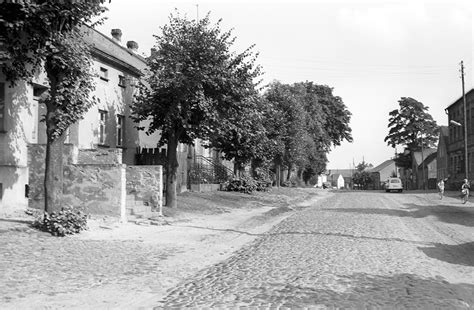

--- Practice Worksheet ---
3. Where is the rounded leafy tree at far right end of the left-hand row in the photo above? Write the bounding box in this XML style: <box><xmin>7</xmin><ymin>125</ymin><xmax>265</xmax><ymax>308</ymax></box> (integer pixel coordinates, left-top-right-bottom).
<box><xmin>264</xmin><ymin>82</ymin><xmax>352</xmax><ymax>181</ymax></box>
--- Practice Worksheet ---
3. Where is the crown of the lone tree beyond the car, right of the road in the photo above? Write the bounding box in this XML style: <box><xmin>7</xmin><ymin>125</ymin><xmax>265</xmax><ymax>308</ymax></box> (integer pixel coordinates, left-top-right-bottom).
<box><xmin>384</xmin><ymin>97</ymin><xmax>439</xmax><ymax>151</ymax></box>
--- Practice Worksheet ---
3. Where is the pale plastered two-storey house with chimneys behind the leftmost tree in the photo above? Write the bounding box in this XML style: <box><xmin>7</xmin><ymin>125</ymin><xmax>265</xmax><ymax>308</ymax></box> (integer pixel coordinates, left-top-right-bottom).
<box><xmin>0</xmin><ymin>27</ymin><xmax>150</xmax><ymax>210</ymax></box>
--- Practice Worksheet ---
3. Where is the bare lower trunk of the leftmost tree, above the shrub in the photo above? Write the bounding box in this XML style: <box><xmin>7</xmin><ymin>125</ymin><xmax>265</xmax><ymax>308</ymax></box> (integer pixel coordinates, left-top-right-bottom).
<box><xmin>44</xmin><ymin>122</ymin><xmax>65</xmax><ymax>213</ymax></box>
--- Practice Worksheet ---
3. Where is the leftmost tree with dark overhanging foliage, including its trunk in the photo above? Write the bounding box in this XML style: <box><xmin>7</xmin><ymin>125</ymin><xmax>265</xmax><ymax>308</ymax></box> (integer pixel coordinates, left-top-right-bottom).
<box><xmin>0</xmin><ymin>0</ymin><xmax>106</xmax><ymax>212</ymax></box>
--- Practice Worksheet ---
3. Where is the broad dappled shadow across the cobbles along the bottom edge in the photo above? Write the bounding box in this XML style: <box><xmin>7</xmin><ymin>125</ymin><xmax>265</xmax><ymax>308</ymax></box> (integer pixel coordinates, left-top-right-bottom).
<box><xmin>159</xmin><ymin>270</ymin><xmax>474</xmax><ymax>309</ymax></box>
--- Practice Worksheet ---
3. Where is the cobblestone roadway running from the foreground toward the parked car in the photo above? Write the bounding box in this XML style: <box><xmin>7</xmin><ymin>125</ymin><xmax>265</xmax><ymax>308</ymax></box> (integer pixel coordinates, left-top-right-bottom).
<box><xmin>160</xmin><ymin>192</ymin><xmax>474</xmax><ymax>309</ymax></box>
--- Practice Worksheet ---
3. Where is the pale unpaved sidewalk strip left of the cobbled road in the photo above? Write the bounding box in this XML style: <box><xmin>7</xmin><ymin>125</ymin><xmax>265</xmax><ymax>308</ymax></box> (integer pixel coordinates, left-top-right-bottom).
<box><xmin>0</xmin><ymin>188</ymin><xmax>332</xmax><ymax>309</ymax></box>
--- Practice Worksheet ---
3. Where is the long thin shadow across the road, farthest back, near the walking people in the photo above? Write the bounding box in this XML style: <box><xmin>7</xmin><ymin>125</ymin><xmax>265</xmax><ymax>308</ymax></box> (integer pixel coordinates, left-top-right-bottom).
<box><xmin>321</xmin><ymin>203</ymin><xmax>474</xmax><ymax>227</ymax></box>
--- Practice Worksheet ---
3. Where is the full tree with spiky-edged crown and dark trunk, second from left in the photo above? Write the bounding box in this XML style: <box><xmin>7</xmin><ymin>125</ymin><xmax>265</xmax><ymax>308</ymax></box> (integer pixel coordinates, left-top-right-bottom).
<box><xmin>132</xmin><ymin>13</ymin><xmax>260</xmax><ymax>208</ymax></box>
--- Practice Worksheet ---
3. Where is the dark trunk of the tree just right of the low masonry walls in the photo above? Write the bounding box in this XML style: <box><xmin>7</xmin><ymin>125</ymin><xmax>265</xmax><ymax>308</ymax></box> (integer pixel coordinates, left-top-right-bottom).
<box><xmin>166</xmin><ymin>131</ymin><xmax>179</xmax><ymax>208</ymax></box>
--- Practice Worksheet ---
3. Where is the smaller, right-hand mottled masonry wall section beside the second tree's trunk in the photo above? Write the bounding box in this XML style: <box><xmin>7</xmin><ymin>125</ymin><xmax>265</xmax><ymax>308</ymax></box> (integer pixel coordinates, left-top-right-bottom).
<box><xmin>126</xmin><ymin>166</ymin><xmax>163</xmax><ymax>206</ymax></box>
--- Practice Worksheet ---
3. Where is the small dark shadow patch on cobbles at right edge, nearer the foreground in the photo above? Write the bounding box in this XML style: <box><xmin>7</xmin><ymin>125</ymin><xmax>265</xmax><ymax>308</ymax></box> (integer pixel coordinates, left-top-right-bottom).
<box><xmin>418</xmin><ymin>242</ymin><xmax>474</xmax><ymax>266</ymax></box>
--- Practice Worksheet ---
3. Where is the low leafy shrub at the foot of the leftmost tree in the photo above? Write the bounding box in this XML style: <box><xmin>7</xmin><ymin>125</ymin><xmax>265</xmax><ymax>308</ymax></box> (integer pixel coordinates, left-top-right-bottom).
<box><xmin>33</xmin><ymin>207</ymin><xmax>87</xmax><ymax>237</ymax></box>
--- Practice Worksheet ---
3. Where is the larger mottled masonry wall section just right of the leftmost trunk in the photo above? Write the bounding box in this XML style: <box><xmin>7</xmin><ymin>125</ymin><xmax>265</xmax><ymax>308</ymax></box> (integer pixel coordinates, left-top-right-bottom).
<box><xmin>63</xmin><ymin>164</ymin><xmax>125</xmax><ymax>217</ymax></box>
